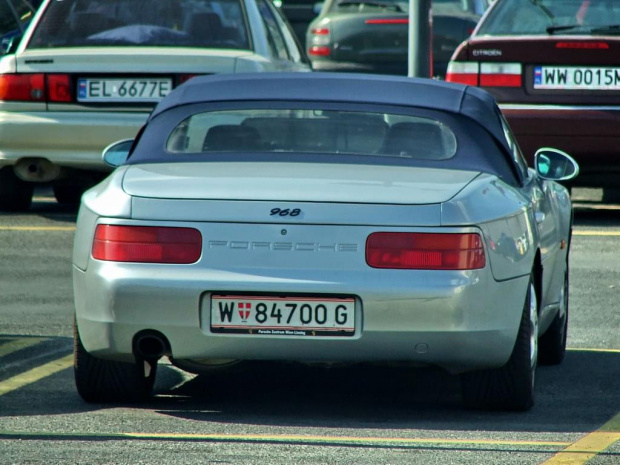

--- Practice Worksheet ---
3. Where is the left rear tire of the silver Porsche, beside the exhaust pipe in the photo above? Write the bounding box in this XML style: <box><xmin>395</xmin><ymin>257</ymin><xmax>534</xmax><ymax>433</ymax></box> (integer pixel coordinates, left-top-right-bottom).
<box><xmin>73</xmin><ymin>324</ymin><xmax>157</xmax><ymax>403</ymax></box>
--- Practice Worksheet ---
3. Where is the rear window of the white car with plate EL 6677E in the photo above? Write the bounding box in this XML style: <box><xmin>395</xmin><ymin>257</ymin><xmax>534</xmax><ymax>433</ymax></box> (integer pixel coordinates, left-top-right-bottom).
<box><xmin>28</xmin><ymin>0</ymin><xmax>250</xmax><ymax>49</ymax></box>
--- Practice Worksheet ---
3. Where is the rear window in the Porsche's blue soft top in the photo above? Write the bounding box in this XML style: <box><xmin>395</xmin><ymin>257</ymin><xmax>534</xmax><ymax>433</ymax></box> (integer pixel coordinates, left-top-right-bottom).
<box><xmin>166</xmin><ymin>109</ymin><xmax>457</xmax><ymax>160</ymax></box>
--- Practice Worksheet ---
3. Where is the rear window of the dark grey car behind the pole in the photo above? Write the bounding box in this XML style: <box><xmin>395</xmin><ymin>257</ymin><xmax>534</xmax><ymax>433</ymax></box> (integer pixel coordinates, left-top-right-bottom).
<box><xmin>331</xmin><ymin>0</ymin><xmax>485</xmax><ymax>15</ymax></box>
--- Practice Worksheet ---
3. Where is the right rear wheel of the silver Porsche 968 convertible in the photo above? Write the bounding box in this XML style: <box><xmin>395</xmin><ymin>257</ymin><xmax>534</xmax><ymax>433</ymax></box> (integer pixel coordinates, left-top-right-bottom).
<box><xmin>461</xmin><ymin>276</ymin><xmax>538</xmax><ymax>411</ymax></box>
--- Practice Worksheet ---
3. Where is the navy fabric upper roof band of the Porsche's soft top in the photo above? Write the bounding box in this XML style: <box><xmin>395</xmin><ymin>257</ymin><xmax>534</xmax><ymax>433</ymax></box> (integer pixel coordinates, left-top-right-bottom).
<box><xmin>150</xmin><ymin>72</ymin><xmax>510</xmax><ymax>152</ymax></box>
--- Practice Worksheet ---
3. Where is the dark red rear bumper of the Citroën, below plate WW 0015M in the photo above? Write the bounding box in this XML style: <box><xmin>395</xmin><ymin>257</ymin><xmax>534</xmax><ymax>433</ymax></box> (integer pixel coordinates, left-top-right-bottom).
<box><xmin>500</xmin><ymin>104</ymin><xmax>620</xmax><ymax>187</ymax></box>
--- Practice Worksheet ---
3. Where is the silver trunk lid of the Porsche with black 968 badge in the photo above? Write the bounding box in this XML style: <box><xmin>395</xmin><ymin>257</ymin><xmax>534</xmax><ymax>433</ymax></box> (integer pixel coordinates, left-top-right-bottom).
<box><xmin>123</xmin><ymin>163</ymin><xmax>479</xmax><ymax>226</ymax></box>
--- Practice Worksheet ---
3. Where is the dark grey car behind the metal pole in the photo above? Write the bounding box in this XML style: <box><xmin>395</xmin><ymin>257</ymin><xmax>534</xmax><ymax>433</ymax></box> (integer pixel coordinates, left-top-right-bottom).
<box><xmin>306</xmin><ymin>0</ymin><xmax>488</xmax><ymax>78</ymax></box>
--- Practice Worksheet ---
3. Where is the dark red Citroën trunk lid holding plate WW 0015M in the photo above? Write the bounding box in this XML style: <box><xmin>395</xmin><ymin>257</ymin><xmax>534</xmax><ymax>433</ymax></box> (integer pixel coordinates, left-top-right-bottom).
<box><xmin>448</xmin><ymin>35</ymin><xmax>620</xmax><ymax>105</ymax></box>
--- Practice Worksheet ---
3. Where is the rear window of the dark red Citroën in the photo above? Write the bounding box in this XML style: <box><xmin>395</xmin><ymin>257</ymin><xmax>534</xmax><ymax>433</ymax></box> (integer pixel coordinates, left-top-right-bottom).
<box><xmin>477</xmin><ymin>0</ymin><xmax>620</xmax><ymax>35</ymax></box>
